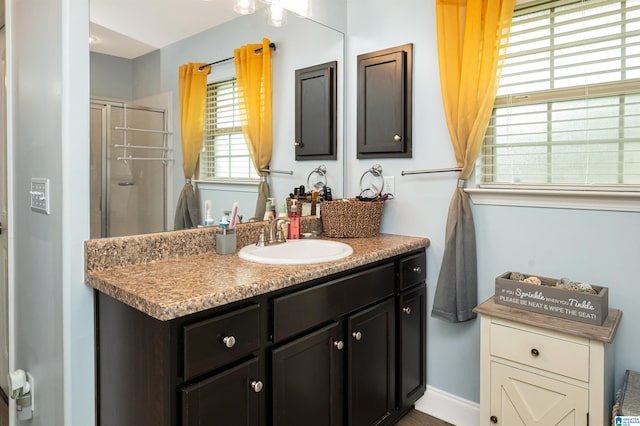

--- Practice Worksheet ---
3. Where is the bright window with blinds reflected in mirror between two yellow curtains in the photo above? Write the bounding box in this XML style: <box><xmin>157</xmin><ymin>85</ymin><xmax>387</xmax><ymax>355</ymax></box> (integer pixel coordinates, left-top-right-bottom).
<box><xmin>200</xmin><ymin>79</ymin><xmax>259</xmax><ymax>181</ymax></box>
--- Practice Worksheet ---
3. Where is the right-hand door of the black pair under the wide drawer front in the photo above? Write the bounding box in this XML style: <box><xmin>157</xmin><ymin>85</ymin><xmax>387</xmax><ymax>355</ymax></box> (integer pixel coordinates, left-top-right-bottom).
<box><xmin>347</xmin><ymin>298</ymin><xmax>395</xmax><ymax>426</ymax></box>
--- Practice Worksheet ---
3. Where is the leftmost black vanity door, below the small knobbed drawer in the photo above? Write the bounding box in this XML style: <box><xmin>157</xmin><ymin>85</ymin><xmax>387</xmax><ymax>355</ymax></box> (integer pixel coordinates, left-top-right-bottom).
<box><xmin>182</xmin><ymin>358</ymin><xmax>263</xmax><ymax>426</ymax></box>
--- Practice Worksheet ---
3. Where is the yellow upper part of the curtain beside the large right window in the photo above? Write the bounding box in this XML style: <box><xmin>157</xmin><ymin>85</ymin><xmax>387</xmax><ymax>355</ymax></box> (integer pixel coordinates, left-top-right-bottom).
<box><xmin>436</xmin><ymin>0</ymin><xmax>515</xmax><ymax>179</ymax></box>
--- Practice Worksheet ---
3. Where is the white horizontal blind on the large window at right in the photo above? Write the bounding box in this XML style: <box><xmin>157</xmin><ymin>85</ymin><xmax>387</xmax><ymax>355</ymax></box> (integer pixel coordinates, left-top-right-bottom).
<box><xmin>478</xmin><ymin>0</ymin><xmax>640</xmax><ymax>190</ymax></box>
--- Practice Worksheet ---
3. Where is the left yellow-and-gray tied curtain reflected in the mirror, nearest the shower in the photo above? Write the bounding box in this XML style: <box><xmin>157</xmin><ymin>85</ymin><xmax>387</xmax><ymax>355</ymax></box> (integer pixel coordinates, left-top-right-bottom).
<box><xmin>174</xmin><ymin>62</ymin><xmax>210</xmax><ymax>229</ymax></box>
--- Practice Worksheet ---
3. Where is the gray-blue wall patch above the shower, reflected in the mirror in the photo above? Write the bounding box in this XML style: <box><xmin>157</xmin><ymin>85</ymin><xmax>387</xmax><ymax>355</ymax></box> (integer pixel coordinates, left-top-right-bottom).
<box><xmin>89</xmin><ymin>52</ymin><xmax>133</xmax><ymax>101</ymax></box>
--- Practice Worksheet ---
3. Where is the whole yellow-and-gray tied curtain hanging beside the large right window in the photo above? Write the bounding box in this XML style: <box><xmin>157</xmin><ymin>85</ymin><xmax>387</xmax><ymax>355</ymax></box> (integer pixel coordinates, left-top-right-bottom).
<box><xmin>431</xmin><ymin>0</ymin><xmax>516</xmax><ymax>322</ymax></box>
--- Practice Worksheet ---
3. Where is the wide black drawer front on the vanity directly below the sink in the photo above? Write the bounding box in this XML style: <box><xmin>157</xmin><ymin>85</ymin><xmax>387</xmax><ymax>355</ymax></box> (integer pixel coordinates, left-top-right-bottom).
<box><xmin>273</xmin><ymin>263</ymin><xmax>395</xmax><ymax>342</ymax></box>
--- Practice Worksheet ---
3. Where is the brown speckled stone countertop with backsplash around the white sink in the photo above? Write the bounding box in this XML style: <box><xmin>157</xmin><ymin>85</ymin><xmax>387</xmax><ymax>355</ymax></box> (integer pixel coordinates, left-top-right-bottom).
<box><xmin>85</xmin><ymin>220</ymin><xmax>429</xmax><ymax>321</ymax></box>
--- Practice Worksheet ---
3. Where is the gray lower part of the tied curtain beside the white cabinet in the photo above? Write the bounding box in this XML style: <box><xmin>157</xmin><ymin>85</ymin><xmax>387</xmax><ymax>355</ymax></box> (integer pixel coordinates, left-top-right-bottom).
<box><xmin>431</xmin><ymin>185</ymin><xmax>478</xmax><ymax>322</ymax></box>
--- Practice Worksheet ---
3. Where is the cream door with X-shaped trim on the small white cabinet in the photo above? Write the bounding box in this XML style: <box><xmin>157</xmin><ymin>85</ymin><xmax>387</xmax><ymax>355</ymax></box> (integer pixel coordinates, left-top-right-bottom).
<box><xmin>490</xmin><ymin>362</ymin><xmax>589</xmax><ymax>426</ymax></box>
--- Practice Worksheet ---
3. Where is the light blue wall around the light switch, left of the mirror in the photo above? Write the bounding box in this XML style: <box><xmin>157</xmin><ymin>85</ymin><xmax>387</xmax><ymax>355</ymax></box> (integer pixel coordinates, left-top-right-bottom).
<box><xmin>7</xmin><ymin>0</ymin><xmax>95</xmax><ymax>426</ymax></box>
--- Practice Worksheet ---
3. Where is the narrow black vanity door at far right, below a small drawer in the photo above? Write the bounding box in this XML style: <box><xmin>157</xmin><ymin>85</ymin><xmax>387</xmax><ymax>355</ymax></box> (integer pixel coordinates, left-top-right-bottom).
<box><xmin>398</xmin><ymin>284</ymin><xmax>427</xmax><ymax>411</ymax></box>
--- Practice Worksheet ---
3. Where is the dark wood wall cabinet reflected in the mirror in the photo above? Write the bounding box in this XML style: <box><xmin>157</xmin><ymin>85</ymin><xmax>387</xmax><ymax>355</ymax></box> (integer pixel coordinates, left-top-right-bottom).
<box><xmin>295</xmin><ymin>61</ymin><xmax>338</xmax><ymax>160</ymax></box>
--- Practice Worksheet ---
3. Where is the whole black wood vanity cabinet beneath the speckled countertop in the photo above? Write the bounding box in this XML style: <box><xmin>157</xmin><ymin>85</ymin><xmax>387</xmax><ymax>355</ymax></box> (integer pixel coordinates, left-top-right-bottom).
<box><xmin>96</xmin><ymin>250</ymin><xmax>426</xmax><ymax>426</ymax></box>
